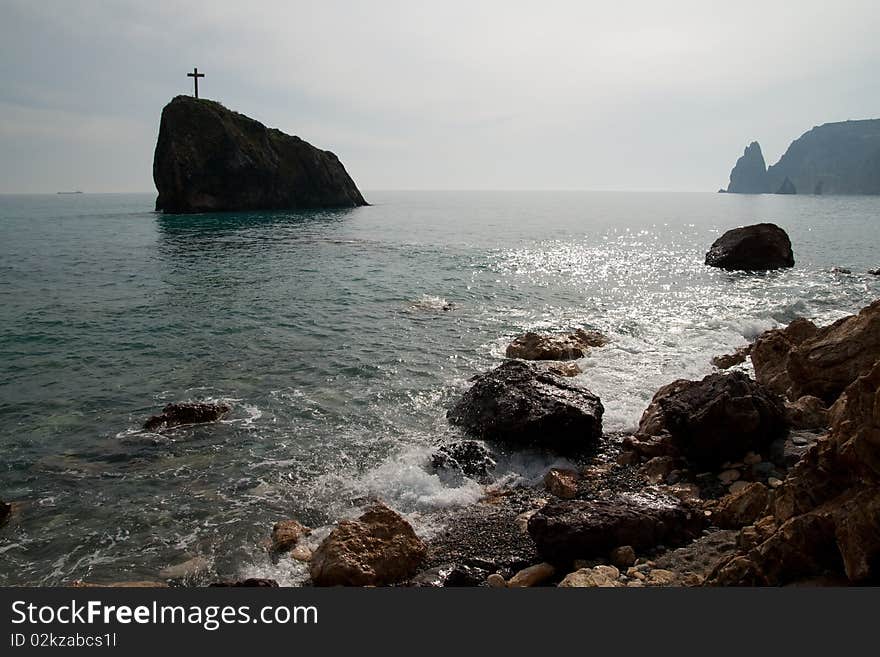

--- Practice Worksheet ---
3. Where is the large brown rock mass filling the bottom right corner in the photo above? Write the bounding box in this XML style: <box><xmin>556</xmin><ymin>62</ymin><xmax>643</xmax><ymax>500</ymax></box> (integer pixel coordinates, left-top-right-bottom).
<box><xmin>707</xmin><ymin>361</ymin><xmax>880</xmax><ymax>585</ymax></box>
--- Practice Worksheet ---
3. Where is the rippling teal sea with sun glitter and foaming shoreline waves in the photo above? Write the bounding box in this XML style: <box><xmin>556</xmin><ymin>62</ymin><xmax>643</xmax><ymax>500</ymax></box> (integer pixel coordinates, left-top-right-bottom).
<box><xmin>0</xmin><ymin>191</ymin><xmax>880</xmax><ymax>586</ymax></box>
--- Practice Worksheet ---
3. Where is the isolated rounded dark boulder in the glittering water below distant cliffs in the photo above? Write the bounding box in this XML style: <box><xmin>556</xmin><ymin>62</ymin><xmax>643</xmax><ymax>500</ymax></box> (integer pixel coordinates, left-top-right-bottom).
<box><xmin>706</xmin><ymin>224</ymin><xmax>794</xmax><ymax>271</ymax></box>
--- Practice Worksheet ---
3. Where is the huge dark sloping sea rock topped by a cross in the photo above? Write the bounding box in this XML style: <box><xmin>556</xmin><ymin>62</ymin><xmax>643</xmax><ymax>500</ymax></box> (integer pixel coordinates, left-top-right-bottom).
<box><xmin>153</xmin><ymin>96</ymin><xmax>367</xmax><ymax>212</ymax></box>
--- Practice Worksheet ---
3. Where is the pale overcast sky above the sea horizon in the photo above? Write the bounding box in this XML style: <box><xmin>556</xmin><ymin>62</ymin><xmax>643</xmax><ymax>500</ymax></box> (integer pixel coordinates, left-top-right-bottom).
<box><xmin>0</xmin><ymin>0</ymin><xmax>880</xmax><ymax>193</ymax></box>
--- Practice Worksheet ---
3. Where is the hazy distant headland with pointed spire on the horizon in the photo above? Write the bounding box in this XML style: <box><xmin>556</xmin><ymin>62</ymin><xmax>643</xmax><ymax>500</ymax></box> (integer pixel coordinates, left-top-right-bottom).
<box><xmin>727</xmin><ymin>119</ymin><xmax>880</xmax><ymax>194</ymax></box>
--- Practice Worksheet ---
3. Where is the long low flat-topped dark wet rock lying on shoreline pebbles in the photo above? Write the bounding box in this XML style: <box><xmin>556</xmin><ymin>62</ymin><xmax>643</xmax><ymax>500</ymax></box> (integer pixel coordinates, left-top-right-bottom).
<box><xmin>528</xmin><ymin>494</ymin><xmax>705</xmax><ymax>564</ymax></box>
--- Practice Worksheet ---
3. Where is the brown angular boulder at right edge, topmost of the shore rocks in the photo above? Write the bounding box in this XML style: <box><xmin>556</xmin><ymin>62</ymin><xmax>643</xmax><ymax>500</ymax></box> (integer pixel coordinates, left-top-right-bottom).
<box><xmin>752</xmin><ymin>300</ymin><xmax>880</xmax><ymax>405</ymax></box>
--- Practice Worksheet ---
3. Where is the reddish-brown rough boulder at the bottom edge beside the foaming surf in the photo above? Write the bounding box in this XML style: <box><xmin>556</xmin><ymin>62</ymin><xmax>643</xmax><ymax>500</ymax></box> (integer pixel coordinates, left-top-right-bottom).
<box><xmin>309</xmin><ymin>503</ymin><xmax>427</xmax><ymax>586</ymax></box>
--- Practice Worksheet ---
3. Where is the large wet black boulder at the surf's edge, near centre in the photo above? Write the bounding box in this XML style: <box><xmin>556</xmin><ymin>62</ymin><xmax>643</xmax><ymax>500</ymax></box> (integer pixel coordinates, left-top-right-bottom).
<box><xmin>447</xmin><ymin>360</ymin><xmax>604</xmax><ymax>454</ymax></box>
